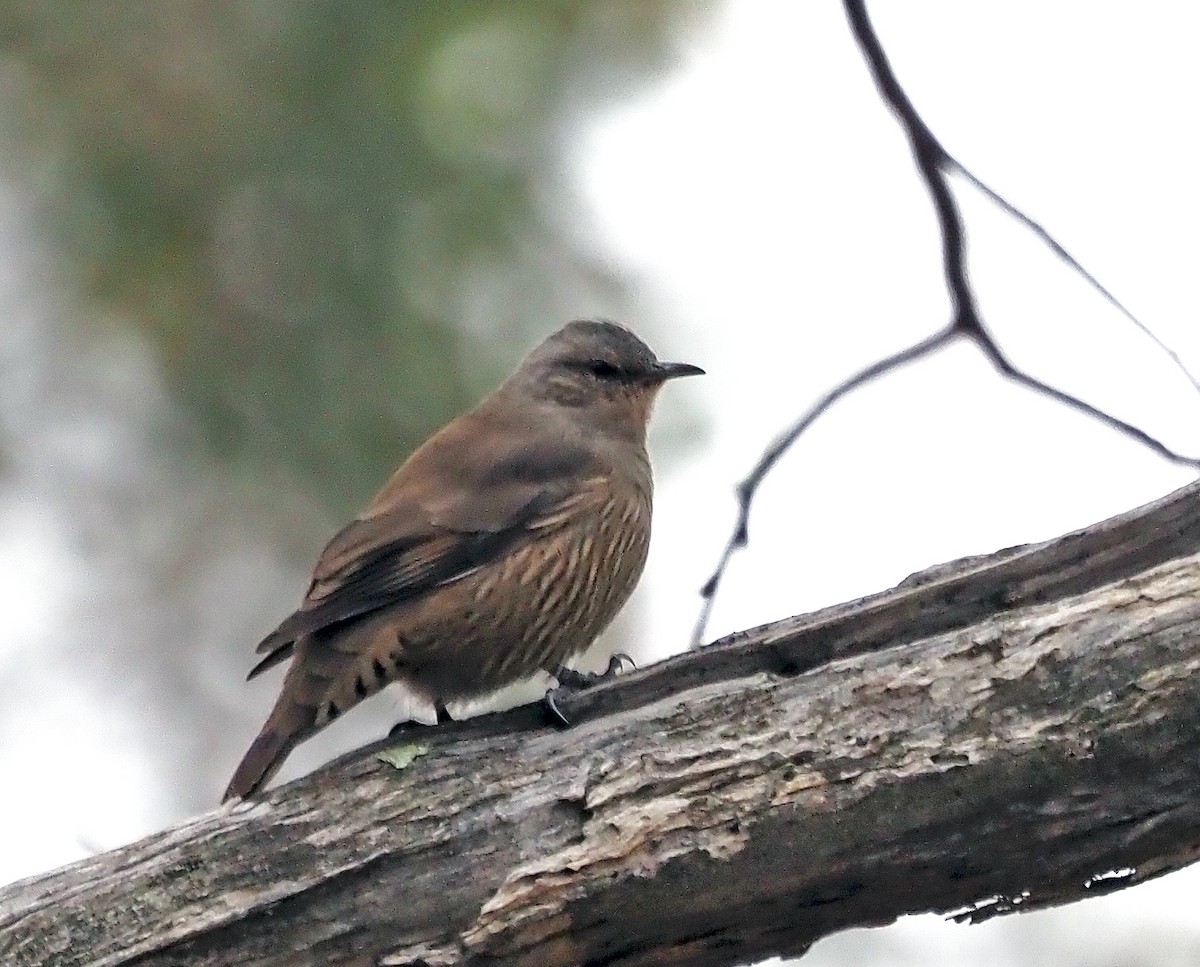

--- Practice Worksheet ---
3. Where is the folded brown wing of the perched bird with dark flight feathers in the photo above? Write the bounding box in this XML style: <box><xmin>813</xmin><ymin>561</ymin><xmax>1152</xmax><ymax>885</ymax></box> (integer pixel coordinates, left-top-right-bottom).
<box><xmin>248</xmin><ymin>400</ymin><xmax>607</xmax><ymax>678</ymax></box>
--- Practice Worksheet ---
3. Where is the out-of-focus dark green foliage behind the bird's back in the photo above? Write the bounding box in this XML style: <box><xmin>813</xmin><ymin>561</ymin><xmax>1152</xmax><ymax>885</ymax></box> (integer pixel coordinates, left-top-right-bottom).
<box><xmin>0</xmin><ymin>0</ymin><xmax>700</xmax><ymax>519</ymax></box>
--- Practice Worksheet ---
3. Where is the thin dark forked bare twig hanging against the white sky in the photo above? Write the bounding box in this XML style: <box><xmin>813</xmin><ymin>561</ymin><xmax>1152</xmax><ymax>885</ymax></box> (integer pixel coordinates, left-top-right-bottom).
<box><xmin>691</xmin><ymin>0</ymin><xmax>1200</xmax><ymax>648</ymax></box>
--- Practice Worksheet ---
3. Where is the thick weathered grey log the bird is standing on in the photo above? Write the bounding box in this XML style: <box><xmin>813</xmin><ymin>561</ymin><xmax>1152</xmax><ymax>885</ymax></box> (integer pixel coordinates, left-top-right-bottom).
<box><xmin>7</xmin><ymin>485</ymin><xmax>1200</xmax><ymax>967</ymax></box>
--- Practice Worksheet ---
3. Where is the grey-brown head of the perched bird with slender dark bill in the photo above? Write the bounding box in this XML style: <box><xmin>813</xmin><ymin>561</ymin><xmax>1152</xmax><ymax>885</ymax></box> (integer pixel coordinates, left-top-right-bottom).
<box><xmin>510</xmin><ymin>320</ymin><xmax>704</xmax><ymax>440</ymax></box>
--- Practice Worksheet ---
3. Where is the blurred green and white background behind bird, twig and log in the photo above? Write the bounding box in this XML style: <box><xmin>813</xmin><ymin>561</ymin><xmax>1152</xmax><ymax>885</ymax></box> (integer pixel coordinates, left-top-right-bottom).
<box><xmin>0</xmin><ymin>0</ymin><xmax>1200</xmax><ymax>967</ymax></box>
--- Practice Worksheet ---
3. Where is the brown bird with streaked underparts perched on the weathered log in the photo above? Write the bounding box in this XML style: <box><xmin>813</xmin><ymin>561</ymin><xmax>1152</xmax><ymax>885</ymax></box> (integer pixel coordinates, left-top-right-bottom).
<box><xmin>222</xmin><ymin>319</ymin><xmax>704</xmax><ymax>801</ymax></box>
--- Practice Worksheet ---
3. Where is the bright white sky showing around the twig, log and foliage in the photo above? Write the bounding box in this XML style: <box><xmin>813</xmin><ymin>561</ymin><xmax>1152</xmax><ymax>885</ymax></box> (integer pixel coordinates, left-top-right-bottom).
<box><xmin>0</xmin><ymin>0</ymin><xmax>1200</xmax><ymax>965</ymax></box>
